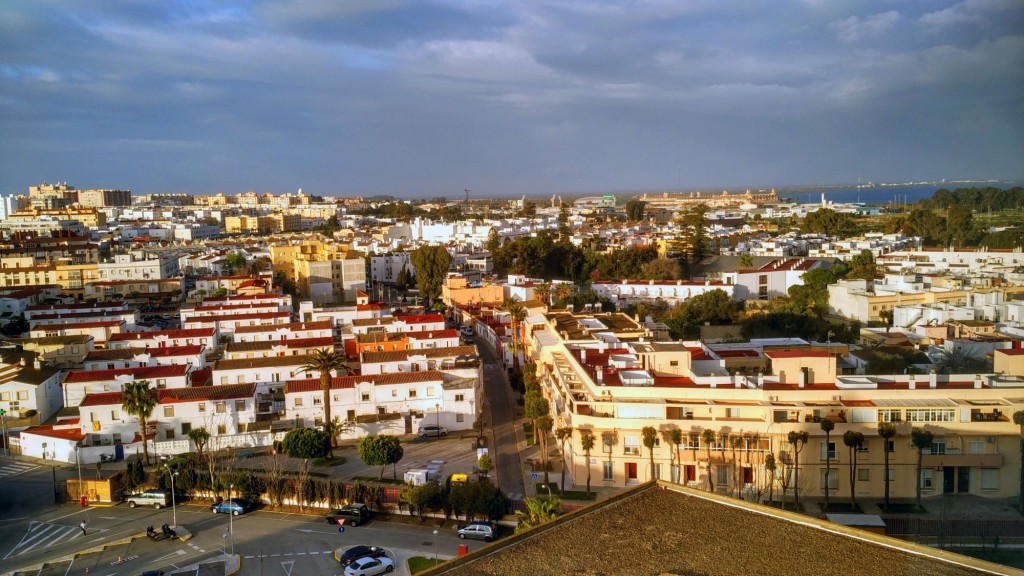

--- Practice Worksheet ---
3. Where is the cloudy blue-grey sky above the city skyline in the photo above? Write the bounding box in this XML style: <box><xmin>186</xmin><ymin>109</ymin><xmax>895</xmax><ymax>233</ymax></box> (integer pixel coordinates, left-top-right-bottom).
<box><xmin>0</xmin><ymin>0</ymin><xmax>1024</xmax><ymax>198</ymax></box>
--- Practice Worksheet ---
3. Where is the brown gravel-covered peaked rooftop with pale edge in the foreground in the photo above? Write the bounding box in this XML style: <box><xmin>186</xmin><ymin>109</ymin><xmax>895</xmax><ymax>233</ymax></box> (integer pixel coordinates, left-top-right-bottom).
<box><xmin>425</xmin><ymin>484</ymin><xmax>1018</xmax><ymax>576</ymax></box>
